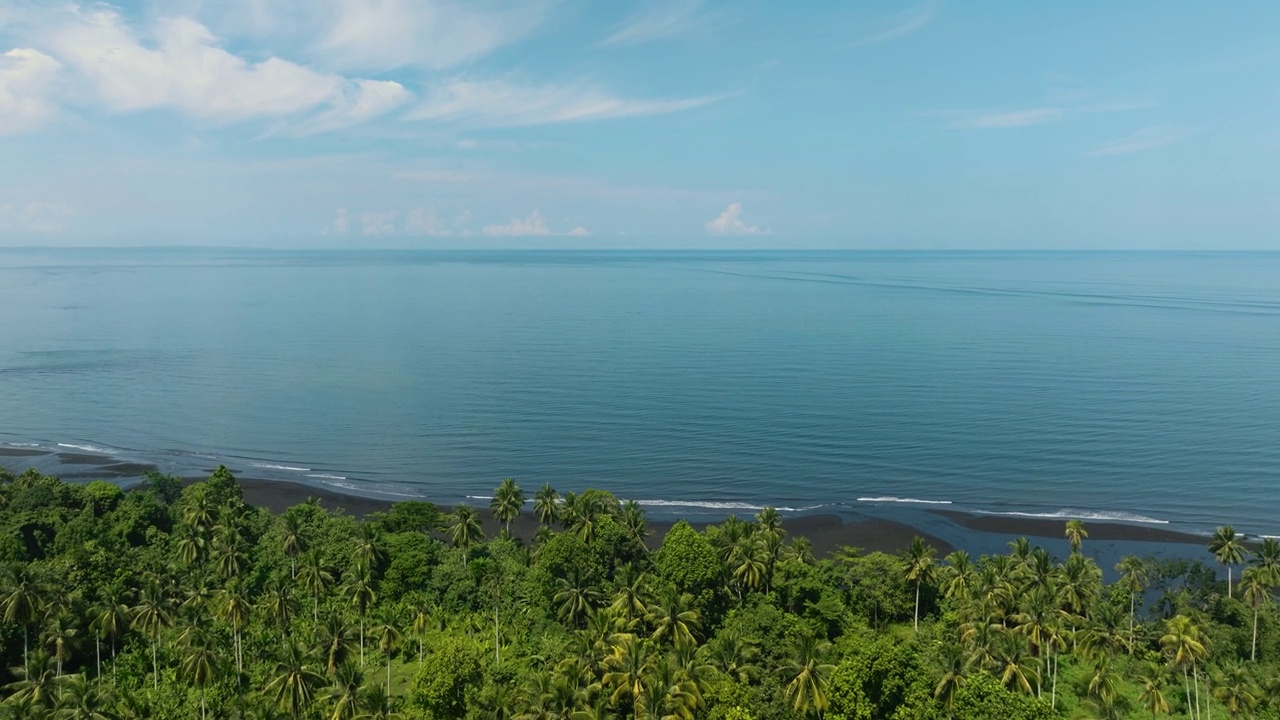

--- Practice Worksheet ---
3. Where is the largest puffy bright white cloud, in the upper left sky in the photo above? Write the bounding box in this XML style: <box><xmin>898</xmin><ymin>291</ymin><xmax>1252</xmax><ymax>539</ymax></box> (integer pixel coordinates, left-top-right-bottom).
<box><xmin>50</xmin><ymin>10</ymin><xmax>408</xmax><ymax>129</ymax></box>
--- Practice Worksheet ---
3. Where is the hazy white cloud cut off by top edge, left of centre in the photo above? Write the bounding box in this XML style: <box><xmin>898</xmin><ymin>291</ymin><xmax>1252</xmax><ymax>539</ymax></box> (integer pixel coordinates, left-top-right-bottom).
<box><xmin>313</xmin><ymin>0</ymin><xmax>547</xmax><ymax>70</ymax></box>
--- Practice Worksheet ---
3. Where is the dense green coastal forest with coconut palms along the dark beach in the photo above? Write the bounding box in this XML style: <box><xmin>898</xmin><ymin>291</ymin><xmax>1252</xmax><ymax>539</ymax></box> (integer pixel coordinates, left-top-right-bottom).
<box><xmin>0</xmin><ymin>461</ymin><xmax>1280</xmax><ymax>720</ymax></box>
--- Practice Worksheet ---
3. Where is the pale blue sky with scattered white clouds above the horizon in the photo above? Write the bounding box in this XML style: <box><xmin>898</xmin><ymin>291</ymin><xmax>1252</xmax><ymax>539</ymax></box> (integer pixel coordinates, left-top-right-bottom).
<box><xmin>0</xmin><ymin>0</ymin><xmax>1280</xmax><ymax>250</ymax></box>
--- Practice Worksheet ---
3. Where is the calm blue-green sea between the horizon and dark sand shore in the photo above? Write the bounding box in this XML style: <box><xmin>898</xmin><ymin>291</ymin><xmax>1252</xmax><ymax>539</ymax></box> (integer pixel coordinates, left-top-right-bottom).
<box><xmin>0</xmin><ymin>250</ymin><xmax>1280</xmax><ymax>533</ymax></box>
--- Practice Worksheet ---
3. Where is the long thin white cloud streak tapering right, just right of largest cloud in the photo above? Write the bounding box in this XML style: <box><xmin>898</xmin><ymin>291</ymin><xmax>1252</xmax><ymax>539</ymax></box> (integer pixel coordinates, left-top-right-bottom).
<box><xmin>408</xmin><ymin>79</ymin><xmax>722</xmax><ymax>126</ymax></box>
